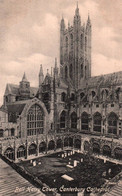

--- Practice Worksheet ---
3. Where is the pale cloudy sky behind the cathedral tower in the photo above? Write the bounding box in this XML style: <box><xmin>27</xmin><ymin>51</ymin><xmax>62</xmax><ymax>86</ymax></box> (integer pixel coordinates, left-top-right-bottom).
<box><xmin>0</xmin><ymin>0</ymin><xmax>122</xmax><ymax>105</ymax></box>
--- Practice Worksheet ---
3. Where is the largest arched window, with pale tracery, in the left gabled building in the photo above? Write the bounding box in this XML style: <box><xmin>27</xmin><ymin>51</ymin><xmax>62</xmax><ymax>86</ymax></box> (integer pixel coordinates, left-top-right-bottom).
<box><xmin>27</xmin><ymin>104</ymin><xmax>44</xmax><ymax>136</ymax></box>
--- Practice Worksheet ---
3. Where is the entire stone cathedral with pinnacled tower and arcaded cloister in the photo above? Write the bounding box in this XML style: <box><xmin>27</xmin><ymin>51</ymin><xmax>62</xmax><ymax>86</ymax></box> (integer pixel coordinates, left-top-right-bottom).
<box><xmin>0</xmin><ymin>6</ymin><xmax>122</xmax><ymax>161</ymax></box>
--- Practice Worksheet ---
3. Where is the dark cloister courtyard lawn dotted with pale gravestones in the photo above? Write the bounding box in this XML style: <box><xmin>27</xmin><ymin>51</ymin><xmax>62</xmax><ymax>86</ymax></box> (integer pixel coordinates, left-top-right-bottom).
<box><xmin>18</xmin><ymin>150</ymin><xmax>122</xmax><ymax>192</ymax></box>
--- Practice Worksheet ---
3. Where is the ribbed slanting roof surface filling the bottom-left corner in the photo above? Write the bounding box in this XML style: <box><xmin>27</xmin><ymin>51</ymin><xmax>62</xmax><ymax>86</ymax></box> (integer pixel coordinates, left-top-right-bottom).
<box><xmin>0</xmin><ymin>159</ymin><xmax>44</xmax><ymax>196</ymax></box>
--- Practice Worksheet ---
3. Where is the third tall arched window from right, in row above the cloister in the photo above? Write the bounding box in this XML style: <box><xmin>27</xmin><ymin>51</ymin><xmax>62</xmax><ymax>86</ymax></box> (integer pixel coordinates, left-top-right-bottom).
<box><xmin>81</xmin><ymin>112</ymin><xmax>89</xmax><ymax>130</ymax></box>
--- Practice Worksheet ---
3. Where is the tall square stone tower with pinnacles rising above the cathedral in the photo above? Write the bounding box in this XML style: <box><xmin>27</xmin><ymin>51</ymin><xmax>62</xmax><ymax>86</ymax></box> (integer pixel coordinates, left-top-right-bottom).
<box><xmin>60</xmin><ymin>5</ymin><xmax>91</xmax><ymax>89</ymax></box>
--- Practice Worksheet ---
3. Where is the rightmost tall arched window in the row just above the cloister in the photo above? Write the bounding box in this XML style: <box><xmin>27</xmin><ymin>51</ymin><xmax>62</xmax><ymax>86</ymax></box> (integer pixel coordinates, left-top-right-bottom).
<box><xmin>108</xmin><ymin>112</ymin><xmax>118</xmax><ymax>134</ymax></box>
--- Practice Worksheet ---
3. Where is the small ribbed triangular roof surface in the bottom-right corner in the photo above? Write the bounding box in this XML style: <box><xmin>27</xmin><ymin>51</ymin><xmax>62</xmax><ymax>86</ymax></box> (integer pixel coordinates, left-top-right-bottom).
<box><xmin>104</xmin><ymin>180</ymin><xmax>122</xmax><ymax>196</ymax></box>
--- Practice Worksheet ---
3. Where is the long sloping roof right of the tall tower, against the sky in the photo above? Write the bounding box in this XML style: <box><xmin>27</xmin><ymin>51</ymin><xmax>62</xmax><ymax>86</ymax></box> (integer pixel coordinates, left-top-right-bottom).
<box><xmin>88</xmin><ymin>71</ymin><xmax>122</xmax><ymax>87</ymax></box>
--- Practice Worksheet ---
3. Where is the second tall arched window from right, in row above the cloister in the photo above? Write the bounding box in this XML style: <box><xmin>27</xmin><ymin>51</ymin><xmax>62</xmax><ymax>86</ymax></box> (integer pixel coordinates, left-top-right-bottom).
<box><xmin>93</xmin><ymin>112</ymin><xmax>102</xmax><ymax>132</ymax></box>
